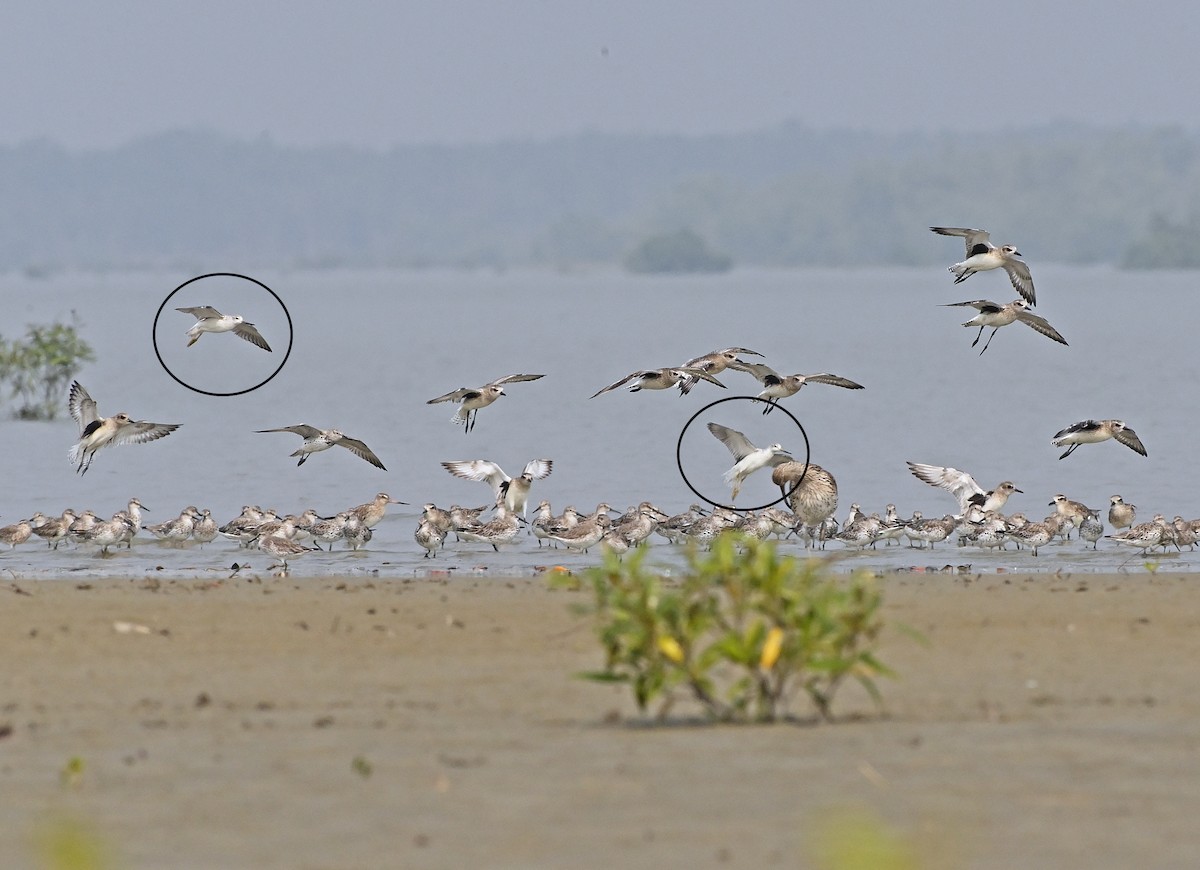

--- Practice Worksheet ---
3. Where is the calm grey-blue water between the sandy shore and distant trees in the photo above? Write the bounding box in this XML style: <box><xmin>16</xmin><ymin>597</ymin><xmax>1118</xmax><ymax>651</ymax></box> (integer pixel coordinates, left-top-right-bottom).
<box><xmin>0</xmin><ymin>264</ymin><xmax>1200</xmax><ymax>576</ymax></box>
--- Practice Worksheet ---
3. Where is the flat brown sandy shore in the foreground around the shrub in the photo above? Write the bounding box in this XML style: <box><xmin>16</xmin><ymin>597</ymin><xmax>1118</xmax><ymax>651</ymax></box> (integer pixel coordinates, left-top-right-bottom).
<box><xmin>0</xmin><ymin>572</ymin><xmax>1200</xmax><ymax>869</ymax></box>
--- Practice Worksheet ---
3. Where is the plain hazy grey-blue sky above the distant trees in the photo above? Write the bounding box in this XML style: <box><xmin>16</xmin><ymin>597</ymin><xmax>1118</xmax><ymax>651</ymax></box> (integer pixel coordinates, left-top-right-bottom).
<box><xmin>0</xmin><ymin>0</ymin><xmax>1200</xmax><ymax>148</ymax></box>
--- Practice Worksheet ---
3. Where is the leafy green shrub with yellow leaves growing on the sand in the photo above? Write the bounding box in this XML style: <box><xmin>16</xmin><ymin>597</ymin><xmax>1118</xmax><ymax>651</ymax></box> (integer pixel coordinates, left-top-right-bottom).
<box><xmin>582</xmin><ymin>535</ymin><xmax>893</xmax><ymax>721</ymax></box>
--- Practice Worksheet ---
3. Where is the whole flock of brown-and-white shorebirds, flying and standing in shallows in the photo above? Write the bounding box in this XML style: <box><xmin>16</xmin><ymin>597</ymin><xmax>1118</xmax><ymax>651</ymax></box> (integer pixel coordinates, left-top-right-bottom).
<box><xmin>0</xmin><ymin>227</ymin><xmax>1180</xmax><ymax>570</ymax></box>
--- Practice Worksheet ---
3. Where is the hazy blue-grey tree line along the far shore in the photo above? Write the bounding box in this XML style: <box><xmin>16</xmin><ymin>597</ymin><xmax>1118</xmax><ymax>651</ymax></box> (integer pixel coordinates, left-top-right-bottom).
<box><xmin>7</xmin><ymin>124</ymin><xmax>1200</xmax><ymax>271</ymax></box>
